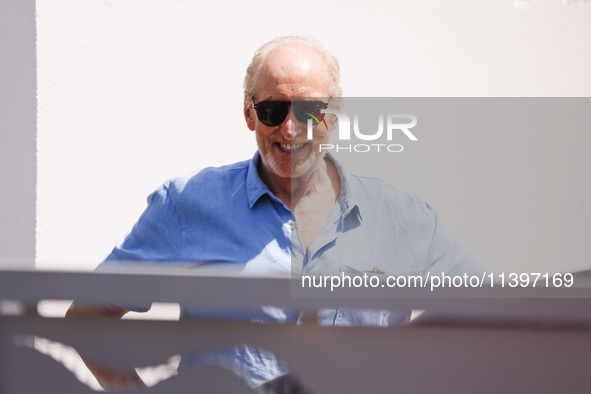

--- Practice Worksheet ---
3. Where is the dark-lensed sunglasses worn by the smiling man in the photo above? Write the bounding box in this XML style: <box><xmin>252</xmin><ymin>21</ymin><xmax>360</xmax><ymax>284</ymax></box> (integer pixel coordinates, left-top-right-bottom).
<box><xmin>252</xmin><ymin>98</ymin><xmax>328</xmax><ymax>127</ymax></box>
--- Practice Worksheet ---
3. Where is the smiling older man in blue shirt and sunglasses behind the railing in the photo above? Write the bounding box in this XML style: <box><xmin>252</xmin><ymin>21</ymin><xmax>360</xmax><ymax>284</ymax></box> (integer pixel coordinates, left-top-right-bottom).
<box><xmin>68</xmin><ymin>37</ymin><xmax>482</xmax><ymax>386</ymax></box>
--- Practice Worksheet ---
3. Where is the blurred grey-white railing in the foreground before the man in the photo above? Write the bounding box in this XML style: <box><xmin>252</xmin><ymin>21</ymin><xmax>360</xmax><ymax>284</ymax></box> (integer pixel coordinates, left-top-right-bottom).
<box><xmin>0</xmin><ymin>270</ymin><xmax>591</xmax><ymax>394</ymax></box>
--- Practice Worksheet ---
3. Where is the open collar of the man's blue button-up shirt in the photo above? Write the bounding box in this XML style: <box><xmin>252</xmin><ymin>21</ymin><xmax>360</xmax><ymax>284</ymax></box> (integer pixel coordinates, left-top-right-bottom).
<box><xmin>246</xmin><ymin>150</ymin><xmax>361</xmax><ymax>220</ymax></box>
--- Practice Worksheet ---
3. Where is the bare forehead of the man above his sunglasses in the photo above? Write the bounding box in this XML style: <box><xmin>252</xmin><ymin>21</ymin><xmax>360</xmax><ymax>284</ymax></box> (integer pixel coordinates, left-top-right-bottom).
<box><xmin>254</xmin><ymin>45</ymin><xmax>328</xmax><ymax>100</ymax></box>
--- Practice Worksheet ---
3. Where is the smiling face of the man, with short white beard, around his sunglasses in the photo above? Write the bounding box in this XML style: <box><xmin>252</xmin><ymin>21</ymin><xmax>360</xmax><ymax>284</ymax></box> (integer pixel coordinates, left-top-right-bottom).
<box><xmin>245</xmin><ymin>46</ymin><xmax>329</xmax><ymax>178</ymax></box>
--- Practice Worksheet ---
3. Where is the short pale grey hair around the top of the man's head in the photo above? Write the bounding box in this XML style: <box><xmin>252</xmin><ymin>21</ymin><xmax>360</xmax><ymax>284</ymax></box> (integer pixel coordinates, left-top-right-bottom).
<box><xmin>244</xmin><ymin>36</ymin><xmax>343</xmax><ymax>97</ymax></box>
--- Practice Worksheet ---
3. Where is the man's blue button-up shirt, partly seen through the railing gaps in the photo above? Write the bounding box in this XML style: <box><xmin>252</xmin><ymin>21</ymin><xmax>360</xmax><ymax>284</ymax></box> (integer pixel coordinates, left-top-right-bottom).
<box><xmin>103</xmin><ymin>152</ymin><xmax>484</xmax><ymax>385</ymax></box>
